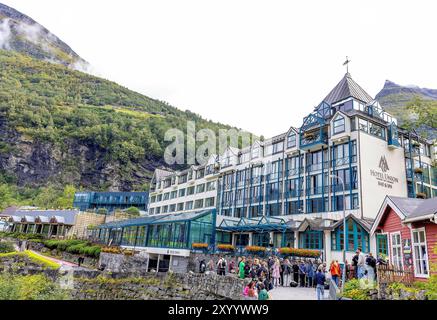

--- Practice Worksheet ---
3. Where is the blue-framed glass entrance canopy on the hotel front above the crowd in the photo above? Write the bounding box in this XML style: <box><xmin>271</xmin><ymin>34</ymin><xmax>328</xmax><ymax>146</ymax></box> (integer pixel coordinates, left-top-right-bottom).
<box><xmin>218</xmin><ymin>217</ymin><xmax>287</xmax><ymax>232</ymax></box>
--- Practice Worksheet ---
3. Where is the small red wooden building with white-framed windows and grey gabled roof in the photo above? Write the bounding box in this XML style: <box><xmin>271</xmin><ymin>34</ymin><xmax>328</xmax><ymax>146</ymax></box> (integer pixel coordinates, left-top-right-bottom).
<box><xmin>371</xmin><ymin>196</ymin><xmax>437</xmax><ymax>280</ymax></box>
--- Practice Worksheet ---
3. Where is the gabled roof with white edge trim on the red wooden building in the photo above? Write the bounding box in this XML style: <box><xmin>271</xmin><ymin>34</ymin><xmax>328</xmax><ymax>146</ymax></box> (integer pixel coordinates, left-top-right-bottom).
<box><xmin>371</xmin><ymin>196</ymin><xmax>437</xmax><ymax>233</ymax></box>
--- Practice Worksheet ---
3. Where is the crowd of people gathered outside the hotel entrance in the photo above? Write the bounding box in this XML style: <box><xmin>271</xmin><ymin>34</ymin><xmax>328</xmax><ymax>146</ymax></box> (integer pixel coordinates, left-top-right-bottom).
<box><xmin>199</xmin><ymin>248</ymin><xmax>386</xmax><ymax>300</ymax></box>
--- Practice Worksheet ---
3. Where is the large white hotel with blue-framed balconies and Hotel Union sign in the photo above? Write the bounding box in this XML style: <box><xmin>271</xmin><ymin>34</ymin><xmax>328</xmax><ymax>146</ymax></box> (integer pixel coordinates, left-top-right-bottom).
<box><xmin>149</xmin><ymin>73</ymin><xmax>437</xmax><ymax>261</ymax></box>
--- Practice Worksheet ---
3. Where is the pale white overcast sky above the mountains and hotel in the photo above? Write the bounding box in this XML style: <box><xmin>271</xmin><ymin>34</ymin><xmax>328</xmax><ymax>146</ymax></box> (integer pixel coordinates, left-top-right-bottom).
<box><xmin>0</xmin><ymin>0</ymin><xmax>437</xmax><ymax>137</ymax></box>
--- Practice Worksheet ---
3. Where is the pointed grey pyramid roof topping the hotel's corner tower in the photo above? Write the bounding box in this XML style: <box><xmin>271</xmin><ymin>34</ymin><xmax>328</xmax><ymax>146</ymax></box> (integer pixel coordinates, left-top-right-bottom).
<box><xmin>323</xmin><ymin>73</ymin><xmax>374</xmax><ymax>105</ymax></box>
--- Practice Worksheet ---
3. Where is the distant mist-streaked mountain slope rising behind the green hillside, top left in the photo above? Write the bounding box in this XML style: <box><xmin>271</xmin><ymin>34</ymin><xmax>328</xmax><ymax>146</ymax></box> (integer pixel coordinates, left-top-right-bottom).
<box><xmin>0</xmin><ymin>3</ymin><xmax>88</xmax><ymax>70</ymax></box>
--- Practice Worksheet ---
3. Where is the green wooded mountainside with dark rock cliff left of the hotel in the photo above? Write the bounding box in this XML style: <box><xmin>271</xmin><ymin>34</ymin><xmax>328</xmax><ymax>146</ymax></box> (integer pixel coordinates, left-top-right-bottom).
<box><xmin>0</xmin><ymin>50</ymin><xmax>238</xmax><ymax>191</ymax></box>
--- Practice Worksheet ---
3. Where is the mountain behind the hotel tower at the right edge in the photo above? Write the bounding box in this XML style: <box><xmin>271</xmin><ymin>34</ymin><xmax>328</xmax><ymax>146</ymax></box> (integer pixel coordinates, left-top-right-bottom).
<box><xmin>376</xmin><ymin>80</ymin><xmax>437</xmax><ymax>139</ymax></box>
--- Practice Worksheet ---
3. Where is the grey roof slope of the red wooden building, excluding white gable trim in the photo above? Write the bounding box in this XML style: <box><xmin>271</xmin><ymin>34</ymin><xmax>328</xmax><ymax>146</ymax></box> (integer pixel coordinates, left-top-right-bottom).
<box><xmin>389</xmin><ymin>196</ymin><xmax>437</xmax><ymax>218</ymax></box>
